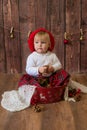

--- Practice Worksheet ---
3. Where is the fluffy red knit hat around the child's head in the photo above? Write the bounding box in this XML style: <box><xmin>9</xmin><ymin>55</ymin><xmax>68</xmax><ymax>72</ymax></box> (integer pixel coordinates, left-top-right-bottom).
<box><xmin>28</xmin><ymin>28</ymin><xmax>55</xmax><ymax>52</ymax></box>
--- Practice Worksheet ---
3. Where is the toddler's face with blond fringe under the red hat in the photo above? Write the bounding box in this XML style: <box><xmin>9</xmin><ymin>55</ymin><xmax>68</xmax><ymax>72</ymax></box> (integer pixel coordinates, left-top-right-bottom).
<box><xmin>34</xmin><ymin>35</ymin><xmax>50</xmax><ymax>53</ymax></box>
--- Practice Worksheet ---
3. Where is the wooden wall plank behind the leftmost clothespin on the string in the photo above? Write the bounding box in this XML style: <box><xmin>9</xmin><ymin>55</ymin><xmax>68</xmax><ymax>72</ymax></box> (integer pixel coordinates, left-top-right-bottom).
<box><xmin>3</xmin><ymin>0</ymin><xmax>21</xmax><ymax>73</ymax></box>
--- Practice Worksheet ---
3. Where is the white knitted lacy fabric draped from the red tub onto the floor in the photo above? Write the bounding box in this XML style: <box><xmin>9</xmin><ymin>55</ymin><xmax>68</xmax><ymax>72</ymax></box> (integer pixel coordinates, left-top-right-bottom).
<box><xmin>1</xmin><ymin>85</ymin><xmax>36</xmax><ymax>112</ymax></box>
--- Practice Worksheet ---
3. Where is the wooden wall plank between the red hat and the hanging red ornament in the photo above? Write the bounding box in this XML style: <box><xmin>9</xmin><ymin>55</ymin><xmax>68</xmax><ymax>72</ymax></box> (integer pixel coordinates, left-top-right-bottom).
<box><xmin>50</xmin><ymin>0</ymin><xmax>65</xmax><ymax>67</ymax></box>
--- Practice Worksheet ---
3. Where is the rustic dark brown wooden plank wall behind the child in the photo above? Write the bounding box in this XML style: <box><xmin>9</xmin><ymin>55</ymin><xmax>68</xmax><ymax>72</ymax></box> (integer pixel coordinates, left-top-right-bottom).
<box><xmin>0</xmin><ymin>0</ymin><xmax>87</xmax><ymax>73</ymax></box>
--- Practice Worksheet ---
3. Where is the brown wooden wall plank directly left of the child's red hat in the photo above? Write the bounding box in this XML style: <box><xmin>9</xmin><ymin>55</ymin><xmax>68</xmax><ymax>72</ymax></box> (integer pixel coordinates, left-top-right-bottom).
<box><xmin>19</xmin><ymin>0</ymin><xmax>35</xmax><ymax>72</ymax></box>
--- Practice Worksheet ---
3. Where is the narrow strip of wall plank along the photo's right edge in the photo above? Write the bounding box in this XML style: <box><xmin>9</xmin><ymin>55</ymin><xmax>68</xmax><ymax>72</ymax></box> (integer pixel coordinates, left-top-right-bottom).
<box><xmin>81</xmin><ymin>0</ymin><xmax>87</xmax><ymax>72</ymax></box>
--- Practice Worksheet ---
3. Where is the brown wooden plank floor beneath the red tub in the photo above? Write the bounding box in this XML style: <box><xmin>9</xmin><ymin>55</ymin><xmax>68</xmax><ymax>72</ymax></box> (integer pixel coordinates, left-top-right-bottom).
<box><xmin>0</xmin><ymin>74</ymin><xmax>87</xmax><ymax>130</ymax></box>
